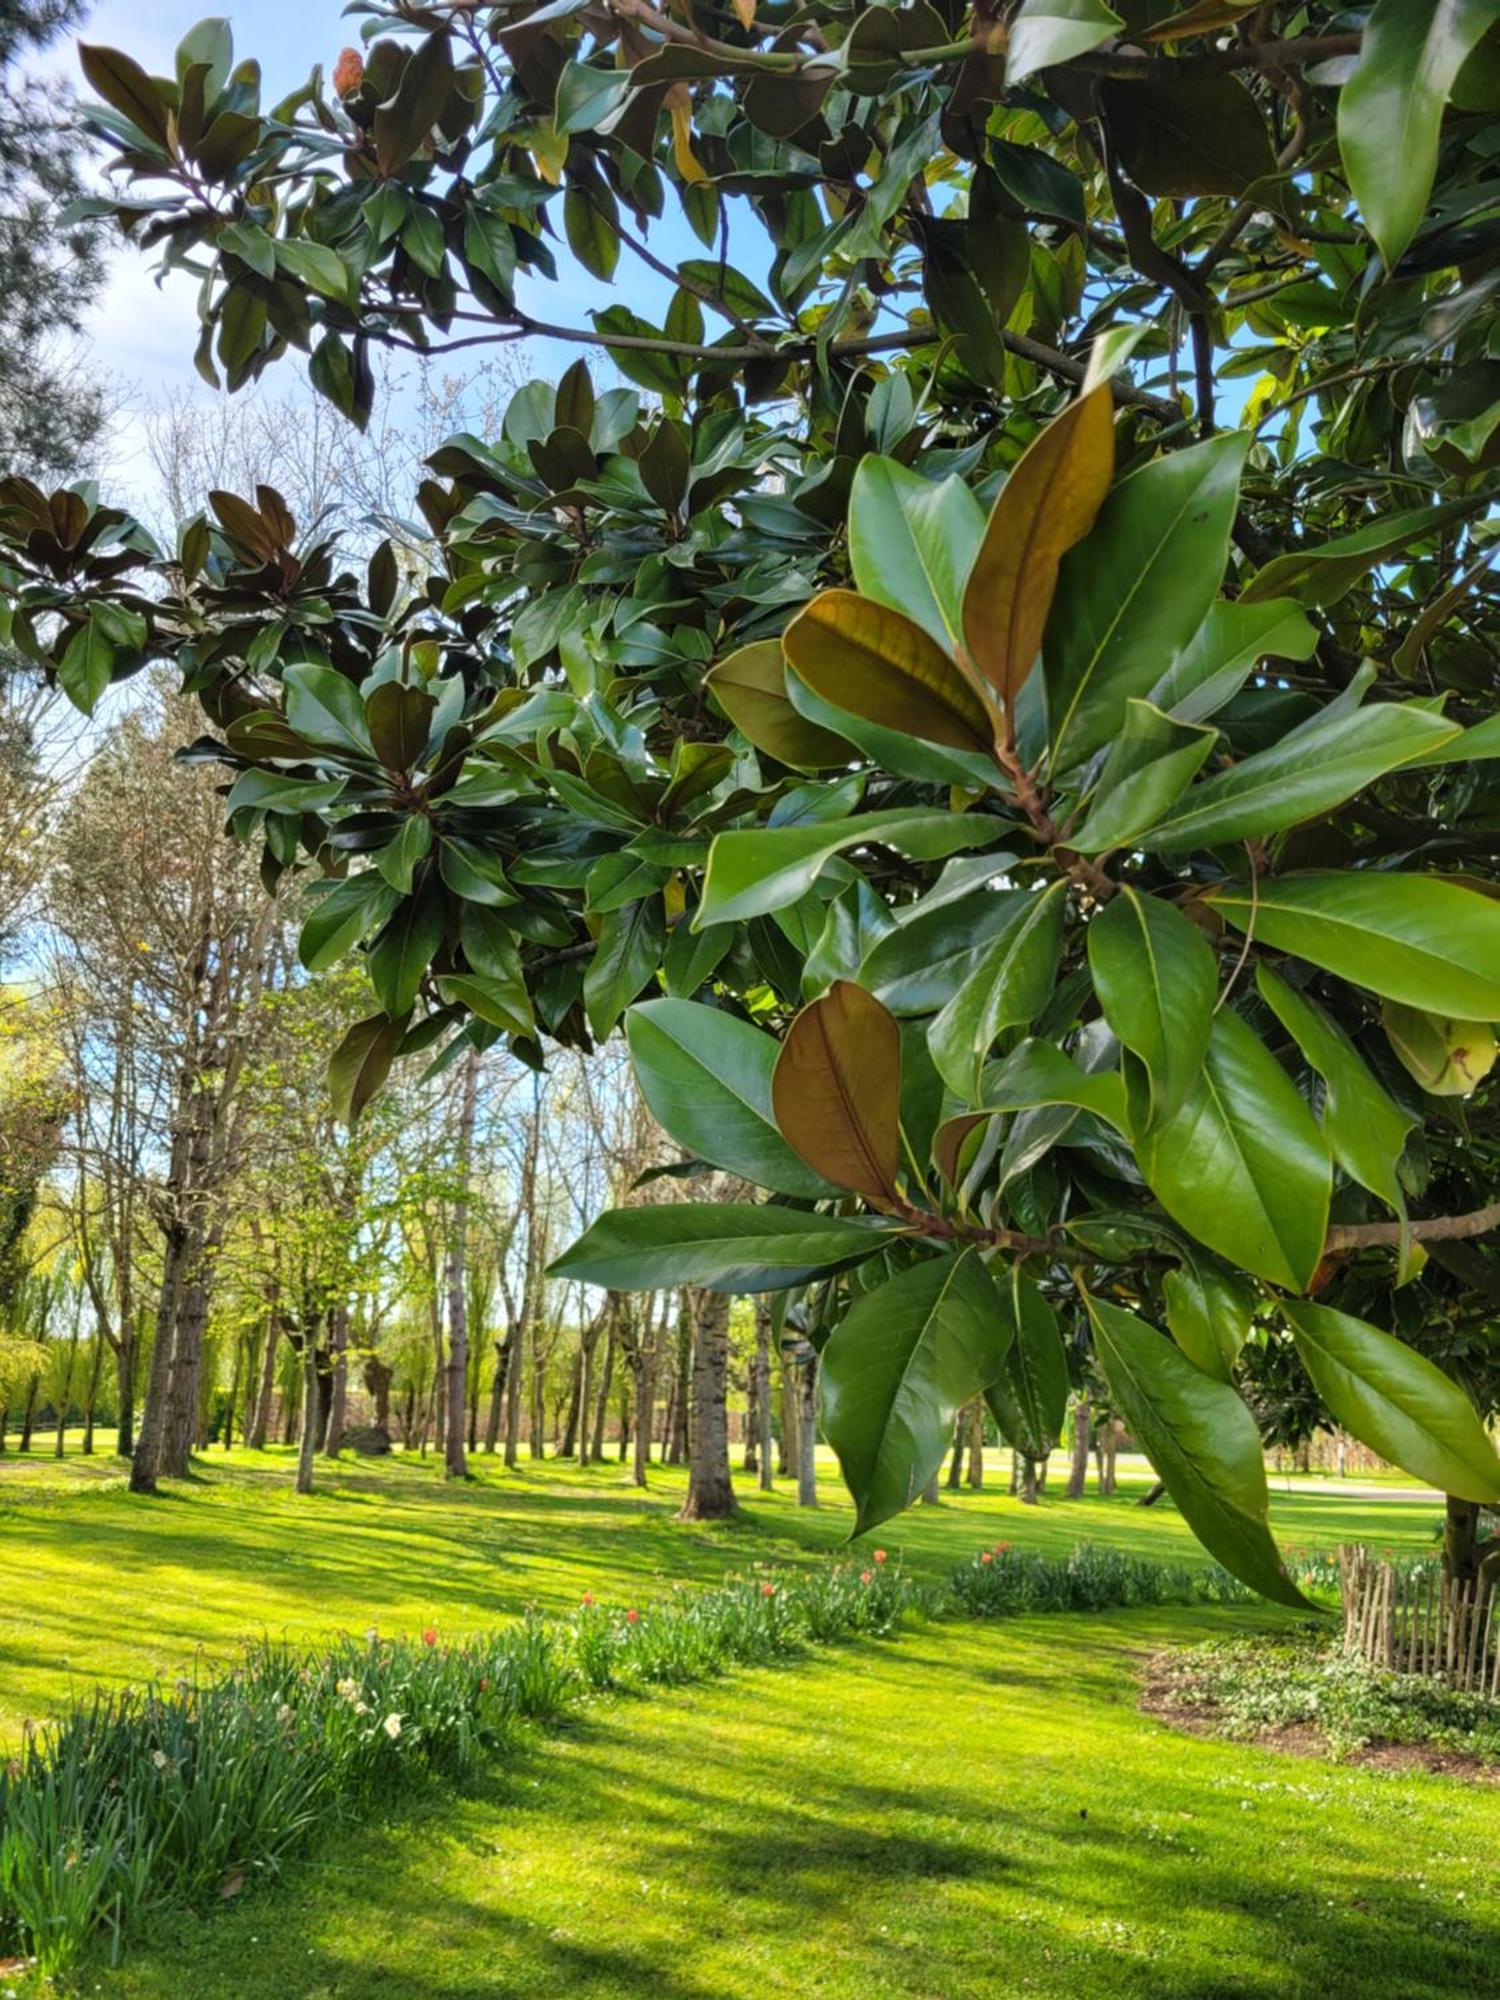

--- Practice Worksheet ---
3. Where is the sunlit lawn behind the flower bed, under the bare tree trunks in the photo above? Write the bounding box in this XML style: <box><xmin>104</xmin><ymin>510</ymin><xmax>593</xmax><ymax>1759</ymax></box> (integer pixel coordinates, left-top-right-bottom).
<box><xmin>0</xmin><ymin>1450</ymin><xmax>1440</xmax><ymax>1738</ymax></box>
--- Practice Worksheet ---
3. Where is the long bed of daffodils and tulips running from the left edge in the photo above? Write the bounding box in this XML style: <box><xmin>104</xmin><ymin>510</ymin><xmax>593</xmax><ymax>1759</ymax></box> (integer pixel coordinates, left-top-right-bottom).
<box><xmin>0</xmin><ymin>1560</ymin><xmax>920</xmax><ymax>1972</ymax></box>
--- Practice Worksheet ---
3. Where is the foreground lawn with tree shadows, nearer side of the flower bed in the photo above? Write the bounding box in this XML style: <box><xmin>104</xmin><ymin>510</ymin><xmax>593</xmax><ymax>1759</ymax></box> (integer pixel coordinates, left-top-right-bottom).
<box><xmin>84</xmin><ymin>1612</ymin><xmax>1500</xmax><ymax>2000</ymax></box>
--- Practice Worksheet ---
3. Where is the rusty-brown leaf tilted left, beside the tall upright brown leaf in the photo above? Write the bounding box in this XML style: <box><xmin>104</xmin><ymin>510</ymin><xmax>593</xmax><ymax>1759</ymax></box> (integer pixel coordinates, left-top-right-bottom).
<box><xmin>782</xmin><ymin>590</ymin><xmax>994</xmax><ymax>752</ymax></box>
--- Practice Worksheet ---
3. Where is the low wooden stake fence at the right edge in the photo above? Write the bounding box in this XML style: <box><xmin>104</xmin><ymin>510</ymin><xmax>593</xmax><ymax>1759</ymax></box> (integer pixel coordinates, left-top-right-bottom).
<box><xmin>1338</xmin><ymin>1544</ymin><xmax>1500</xmax><ymax>1696</ymax></box>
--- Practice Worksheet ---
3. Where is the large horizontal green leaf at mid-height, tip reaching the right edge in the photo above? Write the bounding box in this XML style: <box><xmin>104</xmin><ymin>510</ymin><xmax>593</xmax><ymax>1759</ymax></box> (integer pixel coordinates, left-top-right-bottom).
<box><xmin>1204</xmin><ymin>870</ymin><xmax>1500</xmax><ymax>1020</ymax></box>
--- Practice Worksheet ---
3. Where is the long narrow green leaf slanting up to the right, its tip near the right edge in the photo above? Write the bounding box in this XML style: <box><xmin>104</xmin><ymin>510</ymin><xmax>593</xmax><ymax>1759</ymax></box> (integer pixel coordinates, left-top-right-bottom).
<box><xmin>1136</xmin><ymin>702</ymin><xmax>1458</xmax><ymax>854</ymax></box>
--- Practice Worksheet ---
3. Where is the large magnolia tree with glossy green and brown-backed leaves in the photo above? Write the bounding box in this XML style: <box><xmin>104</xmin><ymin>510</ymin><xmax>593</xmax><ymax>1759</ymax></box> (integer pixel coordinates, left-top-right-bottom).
<box><xmin>0</xmin><ymin>0</ymin><xmax>1500</xmax><ymax>1600</ymax></box>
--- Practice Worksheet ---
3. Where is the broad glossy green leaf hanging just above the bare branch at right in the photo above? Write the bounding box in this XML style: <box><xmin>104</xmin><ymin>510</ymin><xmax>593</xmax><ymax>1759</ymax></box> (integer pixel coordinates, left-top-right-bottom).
<box><xmin>1136</xmin><ymin>1008</ymin><xmax>1332</xmax><ymax>1292</ymax></box>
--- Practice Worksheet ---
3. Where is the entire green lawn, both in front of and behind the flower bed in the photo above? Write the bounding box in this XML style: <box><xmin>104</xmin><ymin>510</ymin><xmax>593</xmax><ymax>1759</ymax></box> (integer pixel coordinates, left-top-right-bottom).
<box><xmin>0</xmin><ymin>1454</ymin><xmax>1500</xmax><ymax>2000</ymax></box>
